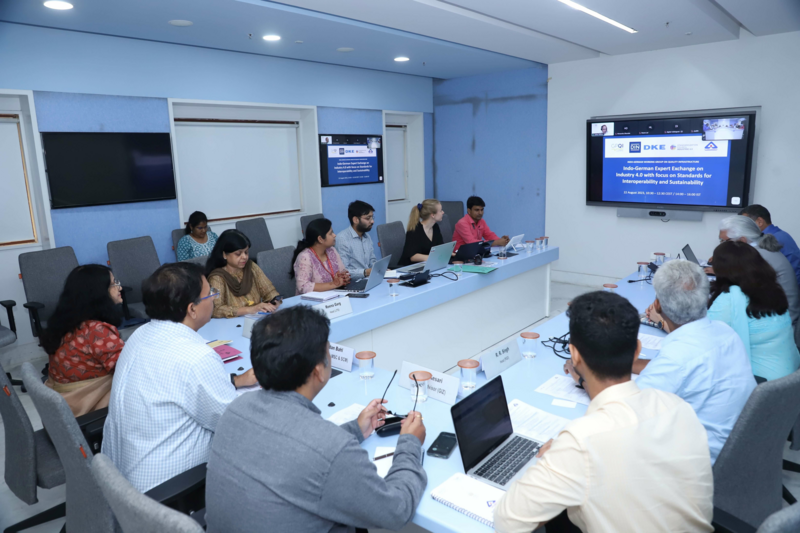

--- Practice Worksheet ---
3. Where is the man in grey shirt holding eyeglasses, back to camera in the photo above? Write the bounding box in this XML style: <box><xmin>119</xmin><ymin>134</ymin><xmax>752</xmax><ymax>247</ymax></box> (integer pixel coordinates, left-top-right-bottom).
<box><xmin>206</xmin><ymin>305</ymin><xmax>427</xmax><ymax>533</ymax></box>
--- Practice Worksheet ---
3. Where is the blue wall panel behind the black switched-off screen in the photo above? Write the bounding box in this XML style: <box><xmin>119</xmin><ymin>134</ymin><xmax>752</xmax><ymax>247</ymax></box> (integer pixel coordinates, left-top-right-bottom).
<box><xmin>34</xmin><ymin>91</ymin><xmax>181</xmax><ymax>264</ymax></box>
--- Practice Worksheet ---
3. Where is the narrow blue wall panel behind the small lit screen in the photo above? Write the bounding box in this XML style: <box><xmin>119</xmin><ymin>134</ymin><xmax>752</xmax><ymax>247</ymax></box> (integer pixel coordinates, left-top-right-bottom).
<box><xmin>317</xmin><ymin>107</ymin><xmax>386</xmax><ymax>257</ymax></box>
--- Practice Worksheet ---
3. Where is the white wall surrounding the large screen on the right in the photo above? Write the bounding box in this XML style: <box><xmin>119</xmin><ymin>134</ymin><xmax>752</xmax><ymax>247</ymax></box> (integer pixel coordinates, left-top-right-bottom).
<box><xmin>546</xmin><ymin>31</ymin><xmax>800</xmax><ymax>284</ymax></box>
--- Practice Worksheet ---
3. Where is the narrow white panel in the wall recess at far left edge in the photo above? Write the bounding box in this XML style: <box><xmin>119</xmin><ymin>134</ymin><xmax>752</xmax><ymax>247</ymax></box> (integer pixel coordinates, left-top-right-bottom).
<box><xmin>0</xmin><ymin>120</ymin><xmax>36</xmax><ymax>246</ymax></box>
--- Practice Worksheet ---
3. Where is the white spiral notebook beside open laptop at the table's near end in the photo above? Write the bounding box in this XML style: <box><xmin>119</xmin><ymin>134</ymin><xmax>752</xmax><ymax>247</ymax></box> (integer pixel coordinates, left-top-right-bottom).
<box><xmin>431</xmin><ymin>473</ymin><xmax>505</xmax><ymax>527</ymax></box>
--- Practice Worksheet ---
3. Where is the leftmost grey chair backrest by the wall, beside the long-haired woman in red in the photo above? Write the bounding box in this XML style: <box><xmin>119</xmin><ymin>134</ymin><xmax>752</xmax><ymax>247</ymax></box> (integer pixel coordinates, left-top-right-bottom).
<box><xmin>19</xmin><ymin>246</ymin><xmax>78</xmax><ymax>337</ymax></box>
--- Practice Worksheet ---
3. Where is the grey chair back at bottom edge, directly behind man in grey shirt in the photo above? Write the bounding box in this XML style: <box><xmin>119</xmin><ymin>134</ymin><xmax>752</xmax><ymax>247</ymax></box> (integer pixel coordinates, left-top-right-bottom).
<box><xmin>92</xmin><ymin>453</ymin><xmax>203</xmax><ymax>533</ymax></box>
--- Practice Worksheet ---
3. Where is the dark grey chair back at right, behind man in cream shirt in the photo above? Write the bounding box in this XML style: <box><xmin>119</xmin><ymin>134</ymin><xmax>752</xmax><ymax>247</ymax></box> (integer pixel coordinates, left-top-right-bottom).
<box><xmin>713</xmin><ymin>371</ymin><xmax>800</xmax><ymax>527</ymax></box>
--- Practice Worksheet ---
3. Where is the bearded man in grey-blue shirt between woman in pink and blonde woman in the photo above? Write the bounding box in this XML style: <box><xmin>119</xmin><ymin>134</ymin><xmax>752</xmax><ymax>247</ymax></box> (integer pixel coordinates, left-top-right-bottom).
<box><xmin>336</xmin><ymin>200</ymin><xmax>378</xmax><ymax>281</ymax></box>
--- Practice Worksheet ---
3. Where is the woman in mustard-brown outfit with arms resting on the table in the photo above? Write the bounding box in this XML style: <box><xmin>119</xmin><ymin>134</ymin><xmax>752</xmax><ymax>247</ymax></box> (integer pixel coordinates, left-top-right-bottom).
<box><xmin>206</xmin><ymin>229</ymin><xmax>281</xmax><ymax>318</ymax></box>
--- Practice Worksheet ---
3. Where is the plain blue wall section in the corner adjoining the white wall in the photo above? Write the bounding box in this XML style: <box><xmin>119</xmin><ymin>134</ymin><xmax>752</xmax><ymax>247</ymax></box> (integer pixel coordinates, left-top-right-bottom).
<box><xmin>426</xmin><ymin>65</ymin><xmax>547</xmax><ymax>243</ymax></box>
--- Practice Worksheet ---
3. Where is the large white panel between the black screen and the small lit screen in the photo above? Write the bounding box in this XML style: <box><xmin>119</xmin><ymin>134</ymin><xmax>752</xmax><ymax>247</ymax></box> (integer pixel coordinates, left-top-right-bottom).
<box><xmin>175</xmin><ymin>122</ymin><xmax>301</xmax><ymax>220</ymax></box>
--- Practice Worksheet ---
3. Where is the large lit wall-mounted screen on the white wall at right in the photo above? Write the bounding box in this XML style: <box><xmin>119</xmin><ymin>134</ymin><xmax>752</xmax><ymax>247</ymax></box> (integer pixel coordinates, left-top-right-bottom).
<box><xmin>586</xmin><ymin>111</ymin><xmax>756</xmax><ymax>211</ymax></box>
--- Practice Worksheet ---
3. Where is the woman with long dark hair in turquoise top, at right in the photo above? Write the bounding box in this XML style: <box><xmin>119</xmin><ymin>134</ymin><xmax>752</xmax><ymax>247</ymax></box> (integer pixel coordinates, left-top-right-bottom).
<box><xmin>708</xmin><ymin>241</ymin><xmax>800</xmax><ymax>380</ymax></box>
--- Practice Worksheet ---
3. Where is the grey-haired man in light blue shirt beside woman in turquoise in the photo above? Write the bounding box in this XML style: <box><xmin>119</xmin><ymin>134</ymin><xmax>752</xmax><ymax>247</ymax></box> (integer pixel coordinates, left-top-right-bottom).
<box><xmin>633</xmin><ymin>260</ymin><xmax>756</xmax><ymax>463</ymax></box>
